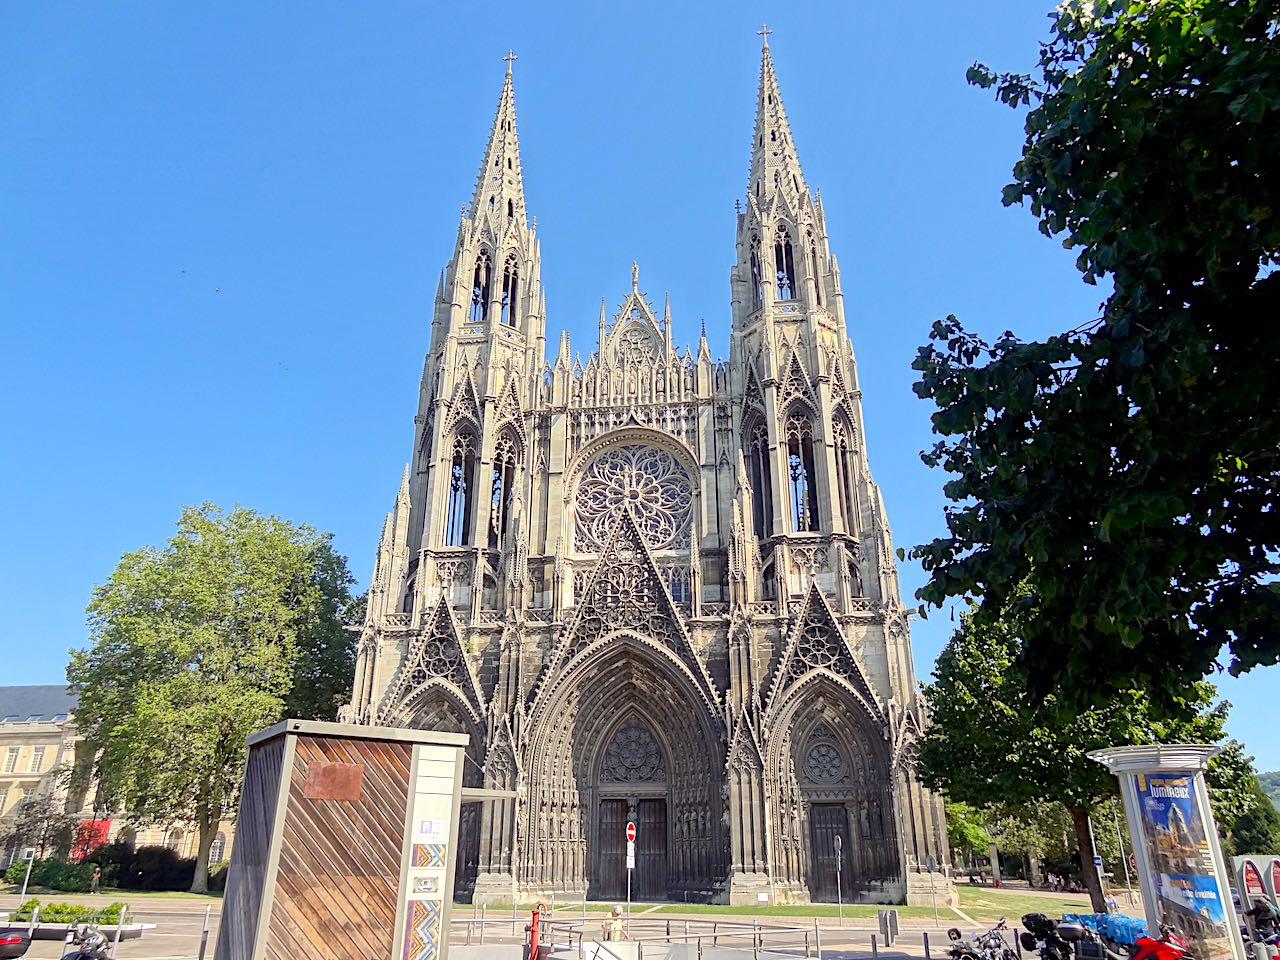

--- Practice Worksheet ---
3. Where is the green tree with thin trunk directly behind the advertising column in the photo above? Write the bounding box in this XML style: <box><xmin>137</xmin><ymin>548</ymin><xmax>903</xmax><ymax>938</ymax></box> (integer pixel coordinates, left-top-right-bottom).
<box><xmin>919</xmin><ymin>614</ymin><xmax>1252</xmax><ymax>911</ymax></box>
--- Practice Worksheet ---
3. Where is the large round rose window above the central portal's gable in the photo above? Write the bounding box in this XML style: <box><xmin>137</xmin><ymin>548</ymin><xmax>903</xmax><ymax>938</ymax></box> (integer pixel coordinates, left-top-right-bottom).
<box><xmin>573</xmin><ymin>444</ymin><xmax>694</xmax><ymax>552</ymax></box>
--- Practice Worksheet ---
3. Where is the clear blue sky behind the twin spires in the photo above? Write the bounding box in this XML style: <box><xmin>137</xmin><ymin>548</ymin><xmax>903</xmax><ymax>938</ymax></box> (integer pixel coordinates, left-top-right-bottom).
<box><xmin>0</xmin><ymin>0</ymin><xmax>1280</xmax><ymax>769</ymax></box>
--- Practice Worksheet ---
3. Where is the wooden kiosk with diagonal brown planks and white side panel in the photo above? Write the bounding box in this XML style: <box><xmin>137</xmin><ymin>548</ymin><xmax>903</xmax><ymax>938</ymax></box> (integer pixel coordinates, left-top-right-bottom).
<box><xmin>216</xmin><ymin>719</ymin><xmax>467</xmax><ymax>960</ymax></box>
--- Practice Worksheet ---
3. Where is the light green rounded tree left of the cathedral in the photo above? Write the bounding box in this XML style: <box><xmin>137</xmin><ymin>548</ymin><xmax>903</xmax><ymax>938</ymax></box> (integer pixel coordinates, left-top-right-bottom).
<box><xmin>67</xmin><ymin>504</ymin><xmax>352</xmax><ymax>892</ymax></box>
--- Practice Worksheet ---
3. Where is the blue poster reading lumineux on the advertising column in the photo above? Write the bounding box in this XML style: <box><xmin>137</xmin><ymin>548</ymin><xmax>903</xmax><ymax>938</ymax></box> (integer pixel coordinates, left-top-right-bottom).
<box><xmin>1134</xmin><ymin>773</ymin><xmax>1234</xmax><ymax>960</ymax></box>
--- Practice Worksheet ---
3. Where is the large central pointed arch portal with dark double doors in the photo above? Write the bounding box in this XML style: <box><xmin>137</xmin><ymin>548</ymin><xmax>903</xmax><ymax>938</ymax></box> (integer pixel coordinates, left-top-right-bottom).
<box><xmin>526</xmin><ymin>632</ymin><xmax>728</xmax><ymax>900</ymax></box>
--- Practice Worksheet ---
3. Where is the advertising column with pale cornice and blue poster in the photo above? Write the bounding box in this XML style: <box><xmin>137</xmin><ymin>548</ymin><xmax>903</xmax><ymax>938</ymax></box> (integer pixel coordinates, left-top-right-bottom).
<box><xmin>1089</xmin><ymin>744</ymin><xmax>1244</xmax><ymax>960</ymax></box>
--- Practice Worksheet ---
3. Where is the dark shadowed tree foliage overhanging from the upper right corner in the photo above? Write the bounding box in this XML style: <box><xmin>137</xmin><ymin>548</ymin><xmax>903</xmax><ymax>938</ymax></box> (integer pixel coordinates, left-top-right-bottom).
<box><xmin>913</xmin><ymin>0</ymin><xmax>1280</xmax><ymax>703</ymax></box>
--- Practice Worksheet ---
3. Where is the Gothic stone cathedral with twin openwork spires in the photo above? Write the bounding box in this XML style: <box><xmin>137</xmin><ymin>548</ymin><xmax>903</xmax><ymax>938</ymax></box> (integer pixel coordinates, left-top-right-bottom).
<box><xmin>344</xmin><ymin>44</ymin><xmax>952</xmax><ymax>902</ymax></box>
